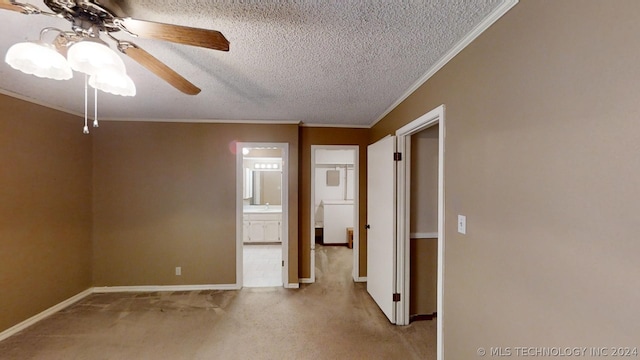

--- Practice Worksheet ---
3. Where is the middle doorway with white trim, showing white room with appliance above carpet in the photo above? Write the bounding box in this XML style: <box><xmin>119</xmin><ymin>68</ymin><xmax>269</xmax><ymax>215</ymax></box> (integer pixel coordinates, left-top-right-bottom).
<box><xmin>302</xmin><ymin>145</ymin><xmax>363</xmax><ymax>283</ymax></box>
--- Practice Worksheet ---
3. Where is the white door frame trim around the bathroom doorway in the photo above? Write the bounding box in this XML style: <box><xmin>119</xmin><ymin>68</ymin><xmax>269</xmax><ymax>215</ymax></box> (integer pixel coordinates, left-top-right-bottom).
<box><xmin>236</xmin><ymin>142</ymin><xmax>293</xmax><ymax>289</ymax></box>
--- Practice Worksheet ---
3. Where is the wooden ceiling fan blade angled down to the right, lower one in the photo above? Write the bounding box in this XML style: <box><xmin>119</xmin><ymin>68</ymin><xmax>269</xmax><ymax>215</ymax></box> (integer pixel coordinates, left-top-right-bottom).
<box><xmin>118</xmin><ymin>42</ymin><xmax>200</xmax><ymax>95</ymax></box>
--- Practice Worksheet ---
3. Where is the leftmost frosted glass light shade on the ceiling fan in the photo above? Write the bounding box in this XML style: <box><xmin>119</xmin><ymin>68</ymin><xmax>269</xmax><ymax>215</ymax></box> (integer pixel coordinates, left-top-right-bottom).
<box><xmin>4</xmin><ymin>41</ymin><xmax>73</xmax><ymax>80</ymax></box>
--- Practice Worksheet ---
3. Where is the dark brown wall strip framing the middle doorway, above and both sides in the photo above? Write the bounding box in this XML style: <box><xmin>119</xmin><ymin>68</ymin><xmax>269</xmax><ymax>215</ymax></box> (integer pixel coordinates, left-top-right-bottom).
<box><xmin>298</xmin><ymin>127</ymin><xmax>369</xmax><ymax>278</ymax></box>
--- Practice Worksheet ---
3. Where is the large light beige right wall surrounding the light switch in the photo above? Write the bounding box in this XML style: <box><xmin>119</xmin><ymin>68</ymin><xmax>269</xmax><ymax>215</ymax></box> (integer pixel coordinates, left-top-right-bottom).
<box><xmin>372</xmin><ymin>0</ymin><xmax>640</xmax><ymax>359</ymax></box>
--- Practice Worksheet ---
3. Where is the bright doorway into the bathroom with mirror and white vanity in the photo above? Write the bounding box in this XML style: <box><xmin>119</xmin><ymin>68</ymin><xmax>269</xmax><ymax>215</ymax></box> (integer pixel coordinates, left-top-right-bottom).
<box><xmin>236</xmin><ymin>143</ymin><xmax>289</xmax><ymax>288</ymax></box>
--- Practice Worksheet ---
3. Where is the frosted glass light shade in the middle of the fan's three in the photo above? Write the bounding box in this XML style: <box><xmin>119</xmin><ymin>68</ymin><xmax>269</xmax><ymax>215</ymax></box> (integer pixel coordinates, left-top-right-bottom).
<box><xmin>67</xmin><ymin>38</ymin><xmax>125</xmax><ymax>75</ymax></box>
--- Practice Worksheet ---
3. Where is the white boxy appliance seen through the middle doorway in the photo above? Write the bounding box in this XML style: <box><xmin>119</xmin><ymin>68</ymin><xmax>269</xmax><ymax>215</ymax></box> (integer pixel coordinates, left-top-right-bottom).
<box><xmin>320</xmin><ymin>200</ymin><xmax>353</xmax><ymax>244</ymax></box>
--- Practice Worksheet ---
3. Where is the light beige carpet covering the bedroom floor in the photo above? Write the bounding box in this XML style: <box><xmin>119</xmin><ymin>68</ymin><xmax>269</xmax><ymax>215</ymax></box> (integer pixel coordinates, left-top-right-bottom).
<box><xmin>0</xmin><ymin>246</ymin><xmax>436</xmax><ymax>360</ymax></box>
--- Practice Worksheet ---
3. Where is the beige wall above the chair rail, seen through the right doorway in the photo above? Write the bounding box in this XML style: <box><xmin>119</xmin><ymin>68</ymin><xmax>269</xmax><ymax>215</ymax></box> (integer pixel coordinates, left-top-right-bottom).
<box><xmin>409</xmin><ymin>125</ymin><xmax>439</xmax><ymax>233</ymax></box>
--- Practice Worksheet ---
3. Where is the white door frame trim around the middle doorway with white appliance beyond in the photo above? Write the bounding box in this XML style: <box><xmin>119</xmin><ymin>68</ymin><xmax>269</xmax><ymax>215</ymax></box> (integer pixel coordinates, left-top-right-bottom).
<box><xmin>304</xmin><ymin>145</ymin><xmax>360</xmax><ymax>283</ymax></box>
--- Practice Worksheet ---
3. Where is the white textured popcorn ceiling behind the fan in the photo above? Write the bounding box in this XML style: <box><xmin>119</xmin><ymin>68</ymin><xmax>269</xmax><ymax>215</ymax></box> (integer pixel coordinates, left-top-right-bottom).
<box><xmin>0</xmin><ymin>0</ymin><xmax>505</xmax><ymax>126</ymax></box>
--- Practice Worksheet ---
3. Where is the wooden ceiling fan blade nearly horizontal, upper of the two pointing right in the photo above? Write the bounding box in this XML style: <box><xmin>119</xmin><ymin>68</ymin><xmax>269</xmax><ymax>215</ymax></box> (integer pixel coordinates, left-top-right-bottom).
<box><xmin>121</xmin><ymin>18</ymin><xmax>229</xmax><ymax>51</ymax></box>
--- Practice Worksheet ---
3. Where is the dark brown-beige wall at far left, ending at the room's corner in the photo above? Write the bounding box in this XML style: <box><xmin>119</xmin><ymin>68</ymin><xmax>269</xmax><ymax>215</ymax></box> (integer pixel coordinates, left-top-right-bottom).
<box><xmin>0</xmin><ymin>95</ymin><xmax>91</xmax><ymax>332</ymax></box>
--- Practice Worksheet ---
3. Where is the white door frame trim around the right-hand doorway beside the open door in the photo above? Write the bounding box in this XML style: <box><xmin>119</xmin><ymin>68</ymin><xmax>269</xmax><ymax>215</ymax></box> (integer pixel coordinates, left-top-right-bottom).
<box><xmin>396</xmin><ymin>104</ymin><xmax>446</xmax><ymax>360</ymax></box>
